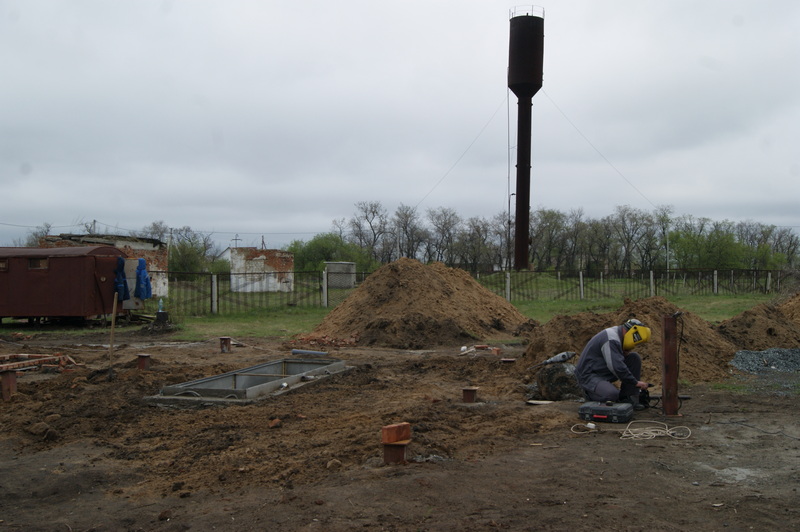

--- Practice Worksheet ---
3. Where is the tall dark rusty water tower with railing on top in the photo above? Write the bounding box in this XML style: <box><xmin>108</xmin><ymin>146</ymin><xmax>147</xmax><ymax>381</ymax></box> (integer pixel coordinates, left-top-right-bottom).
<box><xmin>508</xmin><ymin>6</ymin><xmax>544</xmax><ymax>270</ymax></box>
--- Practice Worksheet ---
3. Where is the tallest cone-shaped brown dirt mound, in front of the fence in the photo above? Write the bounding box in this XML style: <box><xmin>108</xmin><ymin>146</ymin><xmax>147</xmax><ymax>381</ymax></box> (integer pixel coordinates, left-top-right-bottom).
<box><xmin>303</xmin><ymin>258</ymin><xmax>537</xmax><ymax>349</ymax></box>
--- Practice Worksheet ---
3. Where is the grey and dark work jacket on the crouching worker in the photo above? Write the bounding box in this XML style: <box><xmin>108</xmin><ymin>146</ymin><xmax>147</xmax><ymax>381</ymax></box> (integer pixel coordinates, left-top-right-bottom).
<box><xmin>575</xmin><ymin>325</ymin><xmax>638</xmax><ymax>390</ymax></box>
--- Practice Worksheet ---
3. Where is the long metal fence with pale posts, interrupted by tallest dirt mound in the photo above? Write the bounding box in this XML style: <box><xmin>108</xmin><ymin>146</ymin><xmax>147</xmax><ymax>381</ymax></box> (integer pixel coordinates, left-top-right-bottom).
<box><xmin>145</xmin><ymin>270</ymin><xmax>800</xmax><ymax>316</ymax></box>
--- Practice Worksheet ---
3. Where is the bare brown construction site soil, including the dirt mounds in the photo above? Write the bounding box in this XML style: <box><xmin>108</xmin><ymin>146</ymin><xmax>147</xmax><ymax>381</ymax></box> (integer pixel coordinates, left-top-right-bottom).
<box><xmin>0</xmin><ymin>260</ymin><xmax>800</xmax><ymax>531</ymax></box>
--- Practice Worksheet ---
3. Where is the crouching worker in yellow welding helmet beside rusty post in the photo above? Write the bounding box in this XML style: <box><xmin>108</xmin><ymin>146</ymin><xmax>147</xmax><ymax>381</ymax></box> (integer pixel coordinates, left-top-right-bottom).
<box><xmin>575</xmin><ymin>319</ymin><xmax>650</xmax><ymax>410</ymax></box>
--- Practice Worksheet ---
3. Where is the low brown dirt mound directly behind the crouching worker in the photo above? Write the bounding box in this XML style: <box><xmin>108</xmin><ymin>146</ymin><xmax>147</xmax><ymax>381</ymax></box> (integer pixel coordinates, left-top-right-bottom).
<box><xmin>525</xmin><ymin>297</ymin><xmax>742</xmax><ymax>384</ymax></box>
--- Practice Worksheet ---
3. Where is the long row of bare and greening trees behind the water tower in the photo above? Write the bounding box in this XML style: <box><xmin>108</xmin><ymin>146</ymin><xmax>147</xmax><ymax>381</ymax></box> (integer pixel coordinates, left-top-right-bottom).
<box><xmin>324</xmin><ymin>201</ymin><xmax>800</xmax><ymax>272</ymax></box>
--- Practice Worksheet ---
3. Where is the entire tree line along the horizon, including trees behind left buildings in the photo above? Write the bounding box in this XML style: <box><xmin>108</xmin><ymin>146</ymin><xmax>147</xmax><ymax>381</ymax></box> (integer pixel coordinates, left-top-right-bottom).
<box><xmin>24</xmin><ymin>201</ymin><xmax>800</xmax><ymax>274</ymax></box>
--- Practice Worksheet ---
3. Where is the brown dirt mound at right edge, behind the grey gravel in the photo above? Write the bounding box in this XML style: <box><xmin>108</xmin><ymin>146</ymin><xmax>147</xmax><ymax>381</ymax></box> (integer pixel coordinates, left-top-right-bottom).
<box><xmin>717</xmin><ymin>296</ymin><xmax>800</xmax><ymax>351</ymax></box>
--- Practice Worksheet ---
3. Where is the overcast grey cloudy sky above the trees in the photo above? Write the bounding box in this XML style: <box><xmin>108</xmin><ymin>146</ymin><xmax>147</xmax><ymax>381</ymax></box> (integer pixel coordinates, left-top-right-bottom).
<box><xmin>0</xmin><ymin>0</ymin><xmax>800</xmax><ymax>247</ymax></box>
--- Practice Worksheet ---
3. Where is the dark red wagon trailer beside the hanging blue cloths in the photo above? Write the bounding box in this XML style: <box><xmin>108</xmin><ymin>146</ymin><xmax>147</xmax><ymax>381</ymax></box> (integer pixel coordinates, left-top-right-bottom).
<box><xmin>0</xmin><ymin>246</ymin><xmax>125</xmax><ymax>318</ymax></box>
